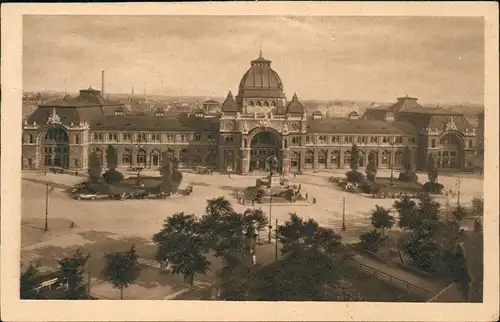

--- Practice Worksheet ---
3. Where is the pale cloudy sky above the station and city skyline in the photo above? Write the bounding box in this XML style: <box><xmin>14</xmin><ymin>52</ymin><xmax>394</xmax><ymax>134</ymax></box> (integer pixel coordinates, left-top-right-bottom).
<box><xmin>23</xmin><ymin>16</ymin><xmax>484</xmax><ymax>104</ymax></box>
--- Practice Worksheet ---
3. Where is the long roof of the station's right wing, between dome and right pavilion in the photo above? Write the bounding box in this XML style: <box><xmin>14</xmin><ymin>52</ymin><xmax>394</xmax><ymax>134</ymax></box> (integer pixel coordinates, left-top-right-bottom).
<box><xmin>307</xmin><ymin>119</ymin><xmax>417</xmax><ymax>135</ymax></box>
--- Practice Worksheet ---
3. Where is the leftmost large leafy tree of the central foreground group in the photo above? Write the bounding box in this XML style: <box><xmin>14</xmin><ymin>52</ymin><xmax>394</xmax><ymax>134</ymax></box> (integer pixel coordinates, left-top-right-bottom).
<box><xmin>153</xmin><ymin>213</ymin><xmax>210</xmax><ymax>286</ymax></box>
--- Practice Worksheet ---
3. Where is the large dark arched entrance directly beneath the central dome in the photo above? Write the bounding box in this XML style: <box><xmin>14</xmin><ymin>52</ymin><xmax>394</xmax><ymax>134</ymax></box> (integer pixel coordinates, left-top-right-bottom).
<box><xmin>250</xmin><ymin>131</ymin><xmax>283</xmax><ymax>171</ymax></box>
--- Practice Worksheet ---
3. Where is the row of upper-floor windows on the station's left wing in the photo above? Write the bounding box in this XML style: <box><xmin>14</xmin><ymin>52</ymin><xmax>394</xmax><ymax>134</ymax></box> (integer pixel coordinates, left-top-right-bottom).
<box><xmin>92</xmin><ymin>133</ymin><xmax>213</xmax><ymax>142</ymax></box>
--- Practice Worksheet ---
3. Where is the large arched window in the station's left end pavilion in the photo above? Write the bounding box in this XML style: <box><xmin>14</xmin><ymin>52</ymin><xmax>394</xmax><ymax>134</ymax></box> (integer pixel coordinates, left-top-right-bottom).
<box><xmin>41</xmin><ymin>126</ymin><xmax>69</xmax><ymax>169</ymax></box>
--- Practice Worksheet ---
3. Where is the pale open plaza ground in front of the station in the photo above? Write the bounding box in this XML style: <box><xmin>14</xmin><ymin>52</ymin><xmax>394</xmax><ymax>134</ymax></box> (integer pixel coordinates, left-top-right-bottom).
<box><xmin>21</xmin><ymin>166</ymin><xmax>482</xmax><ymax>299</ymax></box>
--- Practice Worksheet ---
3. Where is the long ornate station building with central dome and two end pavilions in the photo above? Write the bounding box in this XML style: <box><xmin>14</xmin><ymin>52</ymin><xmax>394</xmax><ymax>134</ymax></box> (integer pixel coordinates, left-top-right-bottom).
<box><xmin>22</xmin><ymin>54</ymin><xmax>476</xmax><ymax>174</ymax></box>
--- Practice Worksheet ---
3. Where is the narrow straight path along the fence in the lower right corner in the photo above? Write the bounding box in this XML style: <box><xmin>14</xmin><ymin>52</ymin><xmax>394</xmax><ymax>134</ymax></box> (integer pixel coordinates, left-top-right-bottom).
<box><xmin>352</xmin><ymin>254</ymin><xmax>446</xmax><ymax>294</ymax></box>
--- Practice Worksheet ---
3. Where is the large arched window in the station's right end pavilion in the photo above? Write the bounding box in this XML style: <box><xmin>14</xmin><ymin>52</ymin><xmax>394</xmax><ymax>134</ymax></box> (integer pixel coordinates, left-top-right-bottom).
<box><xmin>436</xmin><ymin>132</ymin><xmax>464</xmax><ymax>169</ymax></box>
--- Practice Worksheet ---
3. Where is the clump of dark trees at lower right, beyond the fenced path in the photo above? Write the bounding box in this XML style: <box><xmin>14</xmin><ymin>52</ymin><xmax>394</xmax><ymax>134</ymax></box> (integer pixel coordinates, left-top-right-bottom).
<box><xmin>360</xmin><ymin>194</ymin><xmax>483</xmax><ymax>285</ymax></box>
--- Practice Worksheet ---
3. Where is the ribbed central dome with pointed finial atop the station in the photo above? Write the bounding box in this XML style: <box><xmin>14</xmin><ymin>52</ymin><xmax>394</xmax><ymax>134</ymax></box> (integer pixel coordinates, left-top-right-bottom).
<box><xmin>238</xmin><ymin>52</ymin><xmax>284</xmax><ymax>99</ymax></box>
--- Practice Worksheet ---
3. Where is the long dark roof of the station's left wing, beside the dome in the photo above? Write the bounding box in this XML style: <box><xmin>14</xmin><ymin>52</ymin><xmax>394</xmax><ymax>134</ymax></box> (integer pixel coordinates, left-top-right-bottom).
<box><xmin>90</xmin><ymin>113</ymin><xmax>218</xmax><ymax>132</ymax></box>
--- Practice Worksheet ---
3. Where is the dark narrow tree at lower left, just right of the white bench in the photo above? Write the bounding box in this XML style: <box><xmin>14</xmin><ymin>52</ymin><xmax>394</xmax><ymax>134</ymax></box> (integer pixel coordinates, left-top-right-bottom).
<box><xmin>57</xmin><ymin>249</ymin><xmax>90</xmax><ymax>300</ymax></box>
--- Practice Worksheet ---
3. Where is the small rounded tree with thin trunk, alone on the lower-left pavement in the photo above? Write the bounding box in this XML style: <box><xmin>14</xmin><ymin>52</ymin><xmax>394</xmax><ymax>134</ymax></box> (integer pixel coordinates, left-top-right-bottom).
<box><xmin>102</xmin><ymin>245</ymin><xmax>140</xmax><ymax>300</ymax></box>
